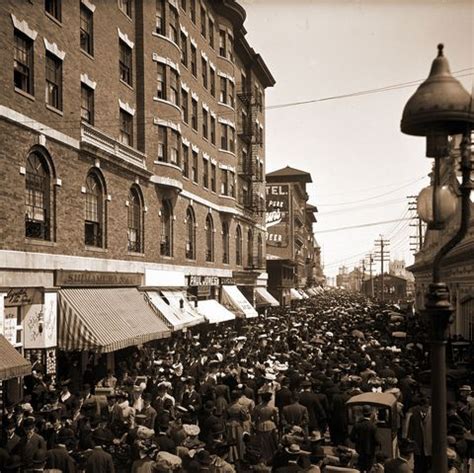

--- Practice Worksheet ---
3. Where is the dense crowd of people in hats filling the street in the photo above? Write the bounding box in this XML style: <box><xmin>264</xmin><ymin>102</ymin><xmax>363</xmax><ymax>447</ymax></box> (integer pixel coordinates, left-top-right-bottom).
<box><xmin>0</xmin><ymin>290</ymin><xmax>474</xmax><ymax>473</ymax></box>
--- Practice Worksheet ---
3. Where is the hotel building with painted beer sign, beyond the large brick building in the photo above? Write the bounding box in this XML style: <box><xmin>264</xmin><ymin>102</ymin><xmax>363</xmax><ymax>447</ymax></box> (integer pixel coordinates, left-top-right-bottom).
<box><xmin>266</xmin><ymin>166</ymin><xmax>320</xmax><ymax>304</ymax></box>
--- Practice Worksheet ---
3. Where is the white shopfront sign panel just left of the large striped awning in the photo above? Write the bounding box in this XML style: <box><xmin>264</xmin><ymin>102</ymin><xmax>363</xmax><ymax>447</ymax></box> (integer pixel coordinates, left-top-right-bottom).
<box><xmin>23</xmin><ymin>292</ymin><xmax>58</xmax><ymax>348</ymax></box>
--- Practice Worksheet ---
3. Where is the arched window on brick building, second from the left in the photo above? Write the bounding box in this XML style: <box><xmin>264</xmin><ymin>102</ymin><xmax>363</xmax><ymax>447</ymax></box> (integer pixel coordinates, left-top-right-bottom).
<box><xmin>84</xmin><ymin>171</ymin><xmax>105</xmax><ymax>248</ymax></box>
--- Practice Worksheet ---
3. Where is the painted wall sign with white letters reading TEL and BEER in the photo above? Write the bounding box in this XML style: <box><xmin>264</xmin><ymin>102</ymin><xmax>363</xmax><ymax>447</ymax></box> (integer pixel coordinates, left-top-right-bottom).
<box><xmin>266</xmin><ymin>184</ymin><xmax>289</xmax><ymax>247</ymax></box>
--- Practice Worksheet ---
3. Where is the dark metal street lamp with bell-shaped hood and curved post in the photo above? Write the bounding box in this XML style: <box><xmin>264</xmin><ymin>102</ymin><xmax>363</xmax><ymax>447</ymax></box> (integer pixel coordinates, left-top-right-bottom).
<box><xmin>401</xmin><ymin>44</ymin><xmax>474</xmax><ymax>473</ymax></box>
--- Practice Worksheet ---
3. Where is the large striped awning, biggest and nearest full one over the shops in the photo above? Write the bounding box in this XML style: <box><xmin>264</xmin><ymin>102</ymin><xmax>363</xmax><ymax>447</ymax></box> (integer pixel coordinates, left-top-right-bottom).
<box><xmin>58</xmin><ymin>287</ymin><xmax>171</xmax><ymax>353</ymax></box>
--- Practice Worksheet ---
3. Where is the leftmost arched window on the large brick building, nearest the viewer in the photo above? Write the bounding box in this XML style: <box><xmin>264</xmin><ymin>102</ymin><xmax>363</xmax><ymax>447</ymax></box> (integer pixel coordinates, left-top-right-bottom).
<box><xmin>25</xmin><ymin>152</ymin><xmax>53</xmax><ymax>240</ymax></box>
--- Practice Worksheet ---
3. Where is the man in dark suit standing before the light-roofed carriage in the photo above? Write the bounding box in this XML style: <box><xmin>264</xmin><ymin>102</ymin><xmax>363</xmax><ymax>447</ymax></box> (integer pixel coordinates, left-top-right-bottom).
<box><xmin>350</xmin><ymin>406</ymin><xmax>380</xmax><ymax>473</ymax></box>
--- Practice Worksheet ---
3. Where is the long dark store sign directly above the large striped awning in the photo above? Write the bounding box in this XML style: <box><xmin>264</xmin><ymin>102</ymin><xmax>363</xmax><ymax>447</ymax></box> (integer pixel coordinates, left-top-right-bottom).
<box><xmin>56</xmin><ymin>270</ymin><xmax>142</xmax><ymax>287</ymax></box>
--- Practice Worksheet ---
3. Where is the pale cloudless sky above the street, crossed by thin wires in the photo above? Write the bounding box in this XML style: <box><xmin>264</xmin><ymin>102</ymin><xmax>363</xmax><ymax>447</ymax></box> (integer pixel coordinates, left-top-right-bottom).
<box><xmin>239</xmin><ymin>0</ymin><xmax>474</xmax><ymax>276</ymax></box>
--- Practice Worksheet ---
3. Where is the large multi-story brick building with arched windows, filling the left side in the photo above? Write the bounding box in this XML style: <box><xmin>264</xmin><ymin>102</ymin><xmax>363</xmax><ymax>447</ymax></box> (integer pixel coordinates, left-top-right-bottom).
<box><xmin>0</xmin><ymin>0</ymin><xmax>275</xmax><ymax>390</ymax></box>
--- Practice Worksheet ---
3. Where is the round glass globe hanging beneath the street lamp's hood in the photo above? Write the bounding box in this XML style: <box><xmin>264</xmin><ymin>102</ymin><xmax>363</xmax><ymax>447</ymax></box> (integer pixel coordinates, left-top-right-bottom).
<box><xmin>416</xmin><ymin>186</ymin><xmax>458</xmax><ymax>225</ymax></box>
